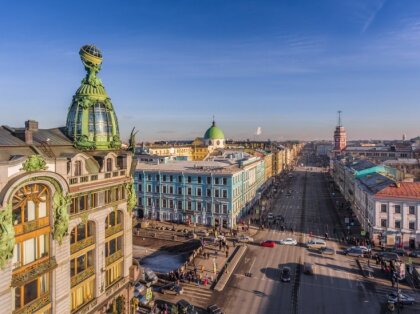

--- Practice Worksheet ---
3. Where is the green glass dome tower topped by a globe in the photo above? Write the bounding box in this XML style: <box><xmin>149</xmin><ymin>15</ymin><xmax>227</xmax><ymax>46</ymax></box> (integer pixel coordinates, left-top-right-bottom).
<box><xmin>66</xmin><ymin>45</ymin><xmax>121</xmax><ymax>150</ymax></box>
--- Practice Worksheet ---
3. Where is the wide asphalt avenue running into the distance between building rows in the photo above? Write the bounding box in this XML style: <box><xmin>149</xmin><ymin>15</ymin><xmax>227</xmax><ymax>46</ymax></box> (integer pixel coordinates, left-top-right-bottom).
<box><xmin>213</xmin><ymin>155</ymin><xmax>415</xmax><ymax>314</ymax></box>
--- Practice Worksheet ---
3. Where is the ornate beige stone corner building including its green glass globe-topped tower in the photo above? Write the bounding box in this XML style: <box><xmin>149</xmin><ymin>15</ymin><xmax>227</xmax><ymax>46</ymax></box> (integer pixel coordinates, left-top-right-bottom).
<box><xmin>0</xmin><ymin>45</ymin><xmax>136</xmax><ymax>314</ymax></box>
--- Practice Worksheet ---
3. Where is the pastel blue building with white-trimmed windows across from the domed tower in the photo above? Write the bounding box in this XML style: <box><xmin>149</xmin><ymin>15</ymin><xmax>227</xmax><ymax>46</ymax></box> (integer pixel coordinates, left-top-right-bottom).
<box><xmin>135</xmin><ymin>151</ymin><xmax>265</xmax><ymax>228</ymax></box>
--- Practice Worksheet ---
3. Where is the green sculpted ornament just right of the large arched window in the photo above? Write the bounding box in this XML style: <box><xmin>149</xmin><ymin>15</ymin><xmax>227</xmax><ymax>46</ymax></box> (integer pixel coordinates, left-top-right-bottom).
<box><xmin>53</xmin><ymin>191</ymin><xmax>71</xmax><ymax>245</ymax></box>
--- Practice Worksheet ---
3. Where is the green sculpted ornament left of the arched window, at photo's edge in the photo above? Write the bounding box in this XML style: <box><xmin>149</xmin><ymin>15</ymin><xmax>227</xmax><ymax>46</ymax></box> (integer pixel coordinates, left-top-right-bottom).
<box><xmin>0</xmin><ymin>205</ymin><xmax>15</xmax><ymax>268</ymax></box>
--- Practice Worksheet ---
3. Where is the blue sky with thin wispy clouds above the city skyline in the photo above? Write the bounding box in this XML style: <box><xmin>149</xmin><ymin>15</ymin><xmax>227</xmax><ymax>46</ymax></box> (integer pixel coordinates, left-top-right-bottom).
<box><xmin>0</xmin><ymin>0</ymin><xmax>420</xmax><ymax>141</ymax></box>
